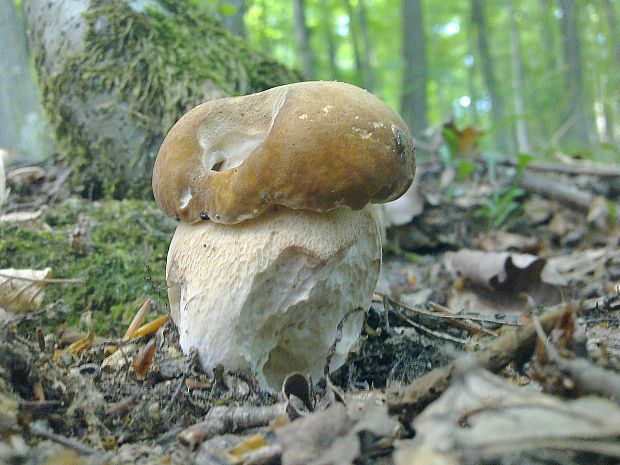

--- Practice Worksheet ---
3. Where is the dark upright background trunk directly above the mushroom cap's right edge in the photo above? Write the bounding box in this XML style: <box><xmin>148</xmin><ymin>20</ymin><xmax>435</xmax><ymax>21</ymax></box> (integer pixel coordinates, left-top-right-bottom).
<box><xmin>400</xmin><ymin>0</ymin><xmax>428</xmax><ymax>135</ymax></box>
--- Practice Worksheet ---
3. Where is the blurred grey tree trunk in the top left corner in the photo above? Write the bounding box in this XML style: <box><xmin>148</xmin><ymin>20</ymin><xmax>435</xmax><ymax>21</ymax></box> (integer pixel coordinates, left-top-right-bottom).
<box><xmin>0</xmin><ymin>0</ymin><xmax>51</xmax><ymax>163</ymax></box>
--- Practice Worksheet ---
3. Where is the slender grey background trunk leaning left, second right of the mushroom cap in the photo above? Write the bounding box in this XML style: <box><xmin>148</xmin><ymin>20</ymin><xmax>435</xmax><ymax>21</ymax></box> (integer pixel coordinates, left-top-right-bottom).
<box><xmin>471</xmin><ymin>0</ymin><xmax>513</xmax><ymax>153</ymax></box>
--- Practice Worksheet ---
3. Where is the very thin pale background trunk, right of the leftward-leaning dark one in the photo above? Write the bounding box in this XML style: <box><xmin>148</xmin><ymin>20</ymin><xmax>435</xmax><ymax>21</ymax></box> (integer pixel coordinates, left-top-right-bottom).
<box><xmin>508</xmin><ymin>4</ymin><xmax>531</xmax><ymax>153</ymax></box>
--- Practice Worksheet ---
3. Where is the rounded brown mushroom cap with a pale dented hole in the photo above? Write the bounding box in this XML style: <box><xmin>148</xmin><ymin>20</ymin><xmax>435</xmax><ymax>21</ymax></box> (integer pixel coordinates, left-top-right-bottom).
<box><xmin>153</xmin><ymin>81</ymin><xmax>415</xmax><ymax>223</ymax></box>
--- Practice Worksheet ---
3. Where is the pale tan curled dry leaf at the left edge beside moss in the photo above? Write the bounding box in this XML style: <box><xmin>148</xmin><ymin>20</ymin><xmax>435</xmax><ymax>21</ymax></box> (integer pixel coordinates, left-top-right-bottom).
<box><xmin>0</xmin><ymin>268</ymin><xmax>52</xmax><ymax>312</ymax></box>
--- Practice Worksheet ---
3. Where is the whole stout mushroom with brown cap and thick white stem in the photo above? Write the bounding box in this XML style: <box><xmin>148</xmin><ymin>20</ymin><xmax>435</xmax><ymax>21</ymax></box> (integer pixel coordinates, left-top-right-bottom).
<box><xmin>153</xmin><ymin>82</ymin><xmax>415</xmax><ymax>390</ymax></box>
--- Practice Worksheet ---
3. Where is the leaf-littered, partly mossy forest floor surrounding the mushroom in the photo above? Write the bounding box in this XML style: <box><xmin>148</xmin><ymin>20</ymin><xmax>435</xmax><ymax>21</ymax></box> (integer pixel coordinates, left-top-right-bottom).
<box><xmin>0</xmin><ymin>153</ymin><xmax>620</xmax><ymax>465</ymax></box>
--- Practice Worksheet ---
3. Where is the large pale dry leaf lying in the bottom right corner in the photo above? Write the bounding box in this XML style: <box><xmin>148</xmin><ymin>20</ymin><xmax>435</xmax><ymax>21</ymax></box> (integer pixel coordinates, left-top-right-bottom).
<box><xmin>395</xmin><ymin>370</ymin><xmax>620</xmax><ymax>465</ymax></box>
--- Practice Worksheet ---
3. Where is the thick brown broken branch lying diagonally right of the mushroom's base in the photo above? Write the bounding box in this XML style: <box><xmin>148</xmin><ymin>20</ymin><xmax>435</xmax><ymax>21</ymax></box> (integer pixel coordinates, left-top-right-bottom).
<box><xmin>387</xmin><ymin>308</ymin><xmax>564</xmax><ymax>414</ymax></box>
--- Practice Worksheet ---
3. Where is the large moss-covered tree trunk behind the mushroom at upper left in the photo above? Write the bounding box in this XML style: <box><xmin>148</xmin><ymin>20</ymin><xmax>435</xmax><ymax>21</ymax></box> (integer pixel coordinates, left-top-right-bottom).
<box><xmin>24</xmin><ymin>0</ymin><xmax>299</xmax><ymax>198</ymax></box>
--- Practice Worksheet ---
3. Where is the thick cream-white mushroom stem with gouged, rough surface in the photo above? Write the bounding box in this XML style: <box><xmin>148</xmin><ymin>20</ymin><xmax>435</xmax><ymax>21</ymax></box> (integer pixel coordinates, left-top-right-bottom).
<box><xmin>166</xmin><ymin>206</ymin><xmax>381</xmax><ymax>390</ymax></box>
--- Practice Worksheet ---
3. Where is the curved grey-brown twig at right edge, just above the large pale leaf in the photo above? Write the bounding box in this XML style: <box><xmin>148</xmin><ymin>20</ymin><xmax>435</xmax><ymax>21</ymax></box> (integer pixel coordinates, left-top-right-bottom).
<box><xmin>532</xmin><ymin>316</ymin><xmax>620</xmax><ymax>401</ymax></box>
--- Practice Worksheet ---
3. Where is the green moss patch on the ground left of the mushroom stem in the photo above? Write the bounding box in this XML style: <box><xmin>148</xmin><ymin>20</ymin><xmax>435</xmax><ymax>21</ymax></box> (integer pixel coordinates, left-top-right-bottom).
<box><xmin>0</xmin><ymin>200</ymin><xmax>174</xmax><ymax>336</ymax></box>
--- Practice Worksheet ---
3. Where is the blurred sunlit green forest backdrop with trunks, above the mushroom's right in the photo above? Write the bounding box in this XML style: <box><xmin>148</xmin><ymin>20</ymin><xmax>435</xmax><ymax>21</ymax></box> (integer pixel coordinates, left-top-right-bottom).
<box><xmin>236</xmin><ymin>0</ymin><xmax>620</xmax><ymax>160</ymax></box>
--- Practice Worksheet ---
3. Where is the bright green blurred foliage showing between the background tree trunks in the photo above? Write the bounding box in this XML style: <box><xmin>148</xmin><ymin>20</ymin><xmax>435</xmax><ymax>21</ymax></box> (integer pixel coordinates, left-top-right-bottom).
<box><xmin>245</xmin><ymin>0</ymin><xmax>620</xmax><ymax>160</ymax></box>
